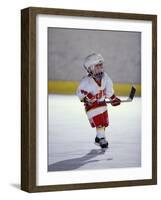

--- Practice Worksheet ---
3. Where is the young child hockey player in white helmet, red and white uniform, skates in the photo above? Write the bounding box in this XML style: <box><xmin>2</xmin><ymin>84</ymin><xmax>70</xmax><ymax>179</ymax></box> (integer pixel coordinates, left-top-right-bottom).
<box><xmin>77</xmin><ymin>53</ymin><xmax>121</xmax><ymax>149</ymax></box>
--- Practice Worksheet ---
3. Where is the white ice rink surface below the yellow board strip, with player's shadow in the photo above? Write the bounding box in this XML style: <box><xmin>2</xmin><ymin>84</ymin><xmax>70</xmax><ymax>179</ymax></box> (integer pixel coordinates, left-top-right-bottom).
<box><xmin>48</xmin><ymin>95</ymin><xmax>141</xmax><ymax>171</ymax></box>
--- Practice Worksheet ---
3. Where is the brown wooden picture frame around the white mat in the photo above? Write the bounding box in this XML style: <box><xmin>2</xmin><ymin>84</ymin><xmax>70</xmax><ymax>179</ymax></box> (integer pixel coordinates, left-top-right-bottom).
<box><xmin>21</xmin><ymin>7</ymin><xmax>157</xmax><ymax>192</ymax></box>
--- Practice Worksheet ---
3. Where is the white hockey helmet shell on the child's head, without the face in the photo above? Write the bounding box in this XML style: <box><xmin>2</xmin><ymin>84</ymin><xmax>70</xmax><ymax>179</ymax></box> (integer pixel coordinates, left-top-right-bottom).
<box><xmin>83</xmin><ymin>53</ymin><xmax>104</xmax><ymax>73</ymax></box>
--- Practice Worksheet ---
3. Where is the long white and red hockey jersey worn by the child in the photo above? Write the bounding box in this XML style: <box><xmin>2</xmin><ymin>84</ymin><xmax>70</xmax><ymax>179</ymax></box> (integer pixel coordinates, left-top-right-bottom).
<box><xmin>77</xmin><ymin>72</ymin><xmax>114</xmax><ymax>127</ymax></box>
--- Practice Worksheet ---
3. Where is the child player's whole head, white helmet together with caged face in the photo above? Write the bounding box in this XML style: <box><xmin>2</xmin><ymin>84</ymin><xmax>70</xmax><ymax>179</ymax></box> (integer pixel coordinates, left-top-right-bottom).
<box><xmin>84</xmin><ymin>53</ymin><xmax>104</xmax><ymax>79</ymax></box>
